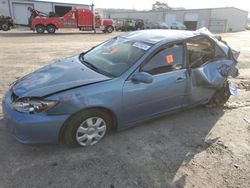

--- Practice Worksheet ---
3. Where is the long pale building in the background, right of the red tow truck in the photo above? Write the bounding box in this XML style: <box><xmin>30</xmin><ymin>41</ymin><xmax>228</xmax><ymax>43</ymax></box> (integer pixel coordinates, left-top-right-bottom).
<box><xmin>107</xmin><ymin>7</ymin><xmax>248</xmax><ymax>32</ymax></box>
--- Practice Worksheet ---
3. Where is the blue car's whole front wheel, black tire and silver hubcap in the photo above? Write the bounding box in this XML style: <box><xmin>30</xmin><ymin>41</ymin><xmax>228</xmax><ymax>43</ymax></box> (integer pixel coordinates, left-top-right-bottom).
<box><xmin>61</xmin><ymin>110</ymin><xmax>112</xmax><ymax>147</ymax></box>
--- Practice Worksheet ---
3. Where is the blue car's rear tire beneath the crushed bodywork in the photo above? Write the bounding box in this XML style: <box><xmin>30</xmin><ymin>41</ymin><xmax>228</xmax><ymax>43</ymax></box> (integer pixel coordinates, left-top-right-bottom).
<box><xmin>208</xmin><ymin>82</ymin><xmax>231</xmax><ymax>106</ymax></box>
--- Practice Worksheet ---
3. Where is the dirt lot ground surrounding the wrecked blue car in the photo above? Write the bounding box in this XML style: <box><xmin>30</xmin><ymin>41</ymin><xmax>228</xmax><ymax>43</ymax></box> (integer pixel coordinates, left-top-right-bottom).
<box><xmin>0</xmin><ymin>29</ymin><xmax>250</xmax><ymax>188</ymax></box>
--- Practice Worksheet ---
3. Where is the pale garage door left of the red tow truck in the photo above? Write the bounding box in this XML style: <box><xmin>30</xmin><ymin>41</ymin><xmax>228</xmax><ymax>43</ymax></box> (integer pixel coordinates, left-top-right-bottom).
<box><xmin>12</xmin><ymin>3</ymin><xmax>34</xmax><ymax>25</ymax></box>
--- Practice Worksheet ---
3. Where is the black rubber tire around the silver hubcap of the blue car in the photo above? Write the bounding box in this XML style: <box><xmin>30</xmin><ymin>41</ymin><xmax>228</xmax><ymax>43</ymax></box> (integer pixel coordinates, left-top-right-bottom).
<box><xmin>60</xmin><ymin>109</ymin><xmax>113</xmax><ymax>147</ymax></box>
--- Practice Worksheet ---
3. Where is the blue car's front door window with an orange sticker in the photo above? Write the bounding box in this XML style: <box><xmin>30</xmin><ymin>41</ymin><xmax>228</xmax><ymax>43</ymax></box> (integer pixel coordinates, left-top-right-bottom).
<box><xmin>140</xmin><ymin>44</ymin><xmax>183</xmax><ymax>75</ymax></box>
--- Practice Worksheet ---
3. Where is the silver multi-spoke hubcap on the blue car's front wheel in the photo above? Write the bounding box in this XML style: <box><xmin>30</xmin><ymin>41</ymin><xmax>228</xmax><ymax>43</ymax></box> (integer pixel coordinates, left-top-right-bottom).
<box><xmin>76</xmin><ymin>117</ymin><xmax>107</xmax><ymax>146</ymax></box>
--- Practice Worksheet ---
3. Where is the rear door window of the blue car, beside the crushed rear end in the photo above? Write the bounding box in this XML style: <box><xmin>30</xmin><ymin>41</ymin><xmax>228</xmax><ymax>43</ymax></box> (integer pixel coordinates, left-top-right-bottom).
<box><xmin>187</xmin><ymin>37</ymin><xmax>226</xmax><ymax>68</ymax></box>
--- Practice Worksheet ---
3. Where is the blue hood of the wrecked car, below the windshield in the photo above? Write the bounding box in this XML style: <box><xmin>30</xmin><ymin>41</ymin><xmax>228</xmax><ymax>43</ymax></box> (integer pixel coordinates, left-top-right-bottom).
<box><xmin>12</xmin><ymin>56</ymin><xmax>111</xmax><ymax>97</ymax></box>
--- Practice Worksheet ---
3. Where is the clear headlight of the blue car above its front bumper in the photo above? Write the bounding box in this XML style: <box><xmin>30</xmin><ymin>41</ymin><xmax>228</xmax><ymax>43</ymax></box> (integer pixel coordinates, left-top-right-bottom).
<box><xmin>12</xmin><ymin>98</ymin><xmax>58</xmax><ymax>114</ymax></box>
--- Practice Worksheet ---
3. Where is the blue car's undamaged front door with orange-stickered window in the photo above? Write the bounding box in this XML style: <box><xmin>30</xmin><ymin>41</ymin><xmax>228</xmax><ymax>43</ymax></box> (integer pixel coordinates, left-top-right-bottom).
<box><xmin>123</xmin><ymin>43</ymin><xmax>188</xmax><ymax>124</ymax></box>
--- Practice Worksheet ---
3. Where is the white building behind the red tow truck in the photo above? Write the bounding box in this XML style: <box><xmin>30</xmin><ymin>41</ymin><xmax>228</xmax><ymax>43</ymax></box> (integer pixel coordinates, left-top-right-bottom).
<box><xmin>0</xmin><ymin>0</ymin><xmax>90</xmax><ymax>25</ymax></box>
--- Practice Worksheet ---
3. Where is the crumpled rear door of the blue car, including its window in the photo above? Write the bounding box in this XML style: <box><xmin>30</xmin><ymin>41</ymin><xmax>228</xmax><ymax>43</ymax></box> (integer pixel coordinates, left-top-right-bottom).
<box><xmin>186</xmin><ymin>36</ymin><xmax>230</xmax><ymax>104</ymax></box>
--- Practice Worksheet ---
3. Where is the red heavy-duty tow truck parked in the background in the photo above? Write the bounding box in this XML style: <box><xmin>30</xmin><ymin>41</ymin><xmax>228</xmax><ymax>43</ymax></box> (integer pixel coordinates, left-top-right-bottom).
<box><xmin>28</xmin><ymin>7</ymin><xmax>114</xmax><ymax>34</ymax></box>
